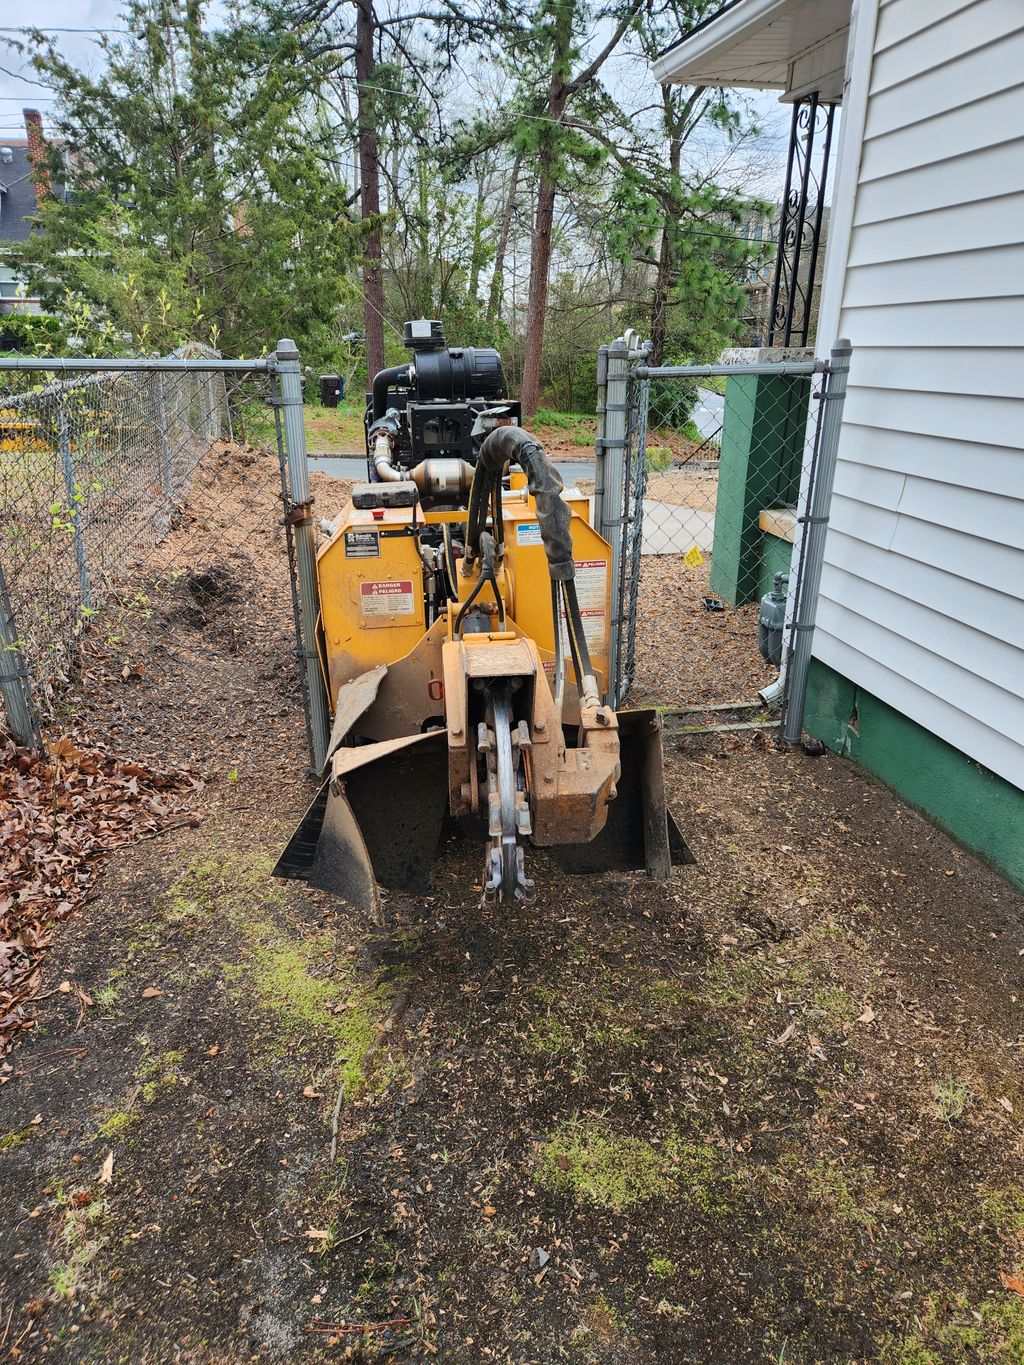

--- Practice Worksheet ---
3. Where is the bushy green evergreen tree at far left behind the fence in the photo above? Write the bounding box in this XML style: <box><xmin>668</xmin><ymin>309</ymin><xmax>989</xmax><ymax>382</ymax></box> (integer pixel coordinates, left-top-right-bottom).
<box><xmin>21</xmin><ymin>0</ymin><xmax>362</xmax><ymax>360</ymax></box>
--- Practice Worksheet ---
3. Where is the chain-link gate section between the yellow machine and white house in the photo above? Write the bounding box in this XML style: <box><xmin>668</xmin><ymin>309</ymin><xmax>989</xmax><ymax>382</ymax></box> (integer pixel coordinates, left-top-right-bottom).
<box><xmin>595</xmin><ymin>333</ymin><xmax>849</xmax><ymax>737</ymax></box>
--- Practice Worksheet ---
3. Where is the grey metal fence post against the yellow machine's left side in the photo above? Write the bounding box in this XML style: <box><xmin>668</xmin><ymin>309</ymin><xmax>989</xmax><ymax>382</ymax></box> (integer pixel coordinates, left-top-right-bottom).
<box><xmin>274</xmin><ymin>337</ymin><xmax>329</xmax><ymax>773</ymax></box>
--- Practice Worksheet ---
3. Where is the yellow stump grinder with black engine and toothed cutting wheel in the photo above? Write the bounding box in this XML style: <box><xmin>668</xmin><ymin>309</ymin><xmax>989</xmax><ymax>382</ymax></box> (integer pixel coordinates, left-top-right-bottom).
<box><xmin>276</xmin><ymin>318</ymin><xmax>689</xmax><ymax>909</ymax></box>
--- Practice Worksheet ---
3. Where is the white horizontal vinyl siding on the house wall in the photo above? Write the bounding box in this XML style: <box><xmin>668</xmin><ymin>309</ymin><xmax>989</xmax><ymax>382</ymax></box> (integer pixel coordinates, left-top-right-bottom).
<box><xmin>814</xmin><ymin>0</ymin><xmax>1024</xmax><ymax>788</ymax></box>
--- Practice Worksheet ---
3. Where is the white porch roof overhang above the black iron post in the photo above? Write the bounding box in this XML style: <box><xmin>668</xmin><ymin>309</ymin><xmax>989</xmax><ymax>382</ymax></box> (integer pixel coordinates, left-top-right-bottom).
<box><xmin>654</xmin><ymin>0</ymin><xmax>852</xmax><ymax>104</ymax></box>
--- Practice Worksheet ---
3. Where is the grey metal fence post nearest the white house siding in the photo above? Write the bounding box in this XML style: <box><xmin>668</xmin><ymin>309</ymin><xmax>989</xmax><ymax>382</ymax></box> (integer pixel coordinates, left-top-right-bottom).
<box><xmin>782</xmin><ymin>337</ymin><xmax>853</xmax><ymax>744</ymax></box>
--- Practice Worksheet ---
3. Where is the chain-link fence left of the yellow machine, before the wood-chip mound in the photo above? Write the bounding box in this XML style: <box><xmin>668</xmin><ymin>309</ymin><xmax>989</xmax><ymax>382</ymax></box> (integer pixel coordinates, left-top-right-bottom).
<box><xmin>0</xmin><ymin>348</ymin><xmax>329</xmax><ymax>769</ymax></box>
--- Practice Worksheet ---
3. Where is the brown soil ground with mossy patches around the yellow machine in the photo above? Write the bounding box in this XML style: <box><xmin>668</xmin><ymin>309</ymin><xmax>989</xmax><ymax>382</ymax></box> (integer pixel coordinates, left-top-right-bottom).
<box><xmin>0</xmin><ymin>442</ymin><xmax>1024</xmax><ymax>1365</ymax></box>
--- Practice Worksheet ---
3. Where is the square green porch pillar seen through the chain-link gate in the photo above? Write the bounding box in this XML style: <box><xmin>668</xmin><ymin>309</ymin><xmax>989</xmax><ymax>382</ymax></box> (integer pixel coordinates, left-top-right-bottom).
<box><xmin>711</xmin><ymin>374</ymin><xmax>811</xmax><ymax>606</ymax></box>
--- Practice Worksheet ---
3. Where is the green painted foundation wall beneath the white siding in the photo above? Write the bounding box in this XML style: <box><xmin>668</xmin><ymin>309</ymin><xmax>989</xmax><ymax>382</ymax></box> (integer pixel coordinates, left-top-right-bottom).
<box><xmin>804</xmin><ymin>659</ymin><xmax>1024</xmax><ymax>891</ymax></box>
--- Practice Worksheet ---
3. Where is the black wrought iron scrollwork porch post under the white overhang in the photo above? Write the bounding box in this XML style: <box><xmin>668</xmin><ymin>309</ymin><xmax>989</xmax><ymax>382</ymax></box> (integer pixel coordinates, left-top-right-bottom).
<box><xmin>766</xmin><ymin>91</ymin><xmax>836</xmax><ymax>345</ymax></box>
